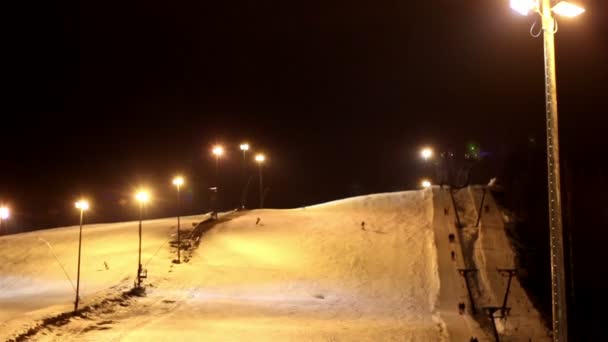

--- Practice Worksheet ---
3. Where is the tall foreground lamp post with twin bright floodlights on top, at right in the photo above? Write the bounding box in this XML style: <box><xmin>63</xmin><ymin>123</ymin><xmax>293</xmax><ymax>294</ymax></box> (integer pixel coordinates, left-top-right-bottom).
<box><xmin>511</xmin><ymin>0</ymin><xmax>585</xmax><ymax>342</ymax></box>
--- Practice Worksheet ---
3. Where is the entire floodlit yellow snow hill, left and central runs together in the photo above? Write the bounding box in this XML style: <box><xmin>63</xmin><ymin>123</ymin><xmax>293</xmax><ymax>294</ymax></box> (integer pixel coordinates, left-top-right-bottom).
<box><xmin>0</xmin><ymin>189</ymin><xmax>552</xmax><ymax>341</ymax></box>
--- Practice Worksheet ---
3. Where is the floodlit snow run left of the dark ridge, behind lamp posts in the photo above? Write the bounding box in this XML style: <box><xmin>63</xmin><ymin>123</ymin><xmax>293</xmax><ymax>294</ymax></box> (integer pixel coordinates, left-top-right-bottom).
<box><xmin>0</xmin><ymin>215</ymin><xmax>205</xmax><ymax>340</ymax></box>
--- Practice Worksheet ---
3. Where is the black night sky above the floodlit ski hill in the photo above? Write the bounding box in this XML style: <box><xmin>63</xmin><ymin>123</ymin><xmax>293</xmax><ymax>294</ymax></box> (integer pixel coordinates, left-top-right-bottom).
<box><xmin>0</xmin><ymin>0</ymin><xmax>608</xmax><ymax>336</ymax></box>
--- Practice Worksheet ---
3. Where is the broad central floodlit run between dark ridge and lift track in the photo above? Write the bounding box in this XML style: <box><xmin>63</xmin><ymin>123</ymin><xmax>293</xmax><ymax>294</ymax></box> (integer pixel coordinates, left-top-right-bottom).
<box><xmin>72</xmin><ymin>192</ymin><xmax>445</xmax><ymax>341</ymax></box>
